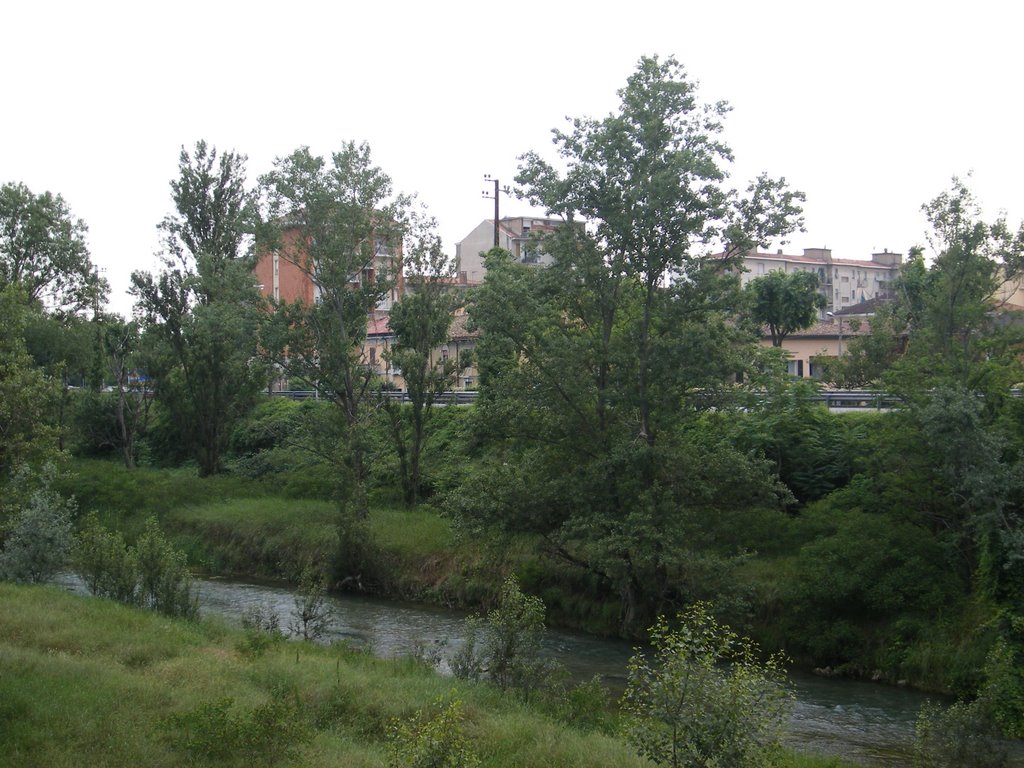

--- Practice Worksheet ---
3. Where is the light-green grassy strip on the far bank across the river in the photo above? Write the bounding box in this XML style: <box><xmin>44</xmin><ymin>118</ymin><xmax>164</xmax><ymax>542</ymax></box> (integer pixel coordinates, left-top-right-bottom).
<box><xmin>62</xmin><ymin>460</ymin><xmax>510</xmax><ymax>605</ymax></box>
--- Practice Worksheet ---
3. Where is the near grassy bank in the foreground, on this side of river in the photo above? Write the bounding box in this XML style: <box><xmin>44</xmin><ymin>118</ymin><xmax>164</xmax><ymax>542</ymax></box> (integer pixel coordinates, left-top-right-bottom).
<box><xmin>0</xmin><ymin>584</ymin><xmax>840</xmax><ymax>768</ymax></box>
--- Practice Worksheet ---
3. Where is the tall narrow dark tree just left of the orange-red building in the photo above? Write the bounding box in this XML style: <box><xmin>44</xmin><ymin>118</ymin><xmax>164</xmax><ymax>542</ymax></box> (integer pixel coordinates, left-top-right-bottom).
<box><xmin>132</xmin><ymin>141</ymin><xmax>266</xmax><ymax>476</ymax></box>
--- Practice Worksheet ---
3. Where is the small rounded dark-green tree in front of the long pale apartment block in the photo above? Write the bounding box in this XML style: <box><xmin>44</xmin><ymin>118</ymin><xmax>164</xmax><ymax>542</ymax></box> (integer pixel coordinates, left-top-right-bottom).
<box><xmin>743</xmin><ymin>270</ymin><xmax>826</xmax><ymax>347</ymax></box>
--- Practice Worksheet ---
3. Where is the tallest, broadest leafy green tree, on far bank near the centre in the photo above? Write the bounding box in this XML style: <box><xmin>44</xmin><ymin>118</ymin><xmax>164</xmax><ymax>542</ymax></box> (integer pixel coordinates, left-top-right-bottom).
<box><xmin>456</xmin><ymin>58</ymin><xmax>800</xmax><ymax>628</ymax></box>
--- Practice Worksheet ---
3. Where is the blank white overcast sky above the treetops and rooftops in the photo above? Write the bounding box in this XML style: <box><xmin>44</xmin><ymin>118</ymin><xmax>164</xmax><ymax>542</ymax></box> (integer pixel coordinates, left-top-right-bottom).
<box><xmin>0</xmin><ymin>0</ymin><xmax>1024</xmax><ymax>313</ymax></box>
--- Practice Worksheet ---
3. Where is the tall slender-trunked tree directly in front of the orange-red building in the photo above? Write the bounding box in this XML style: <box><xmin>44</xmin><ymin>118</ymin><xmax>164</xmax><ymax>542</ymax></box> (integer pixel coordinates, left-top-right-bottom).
<box><xmin>260</xmin><ymin>142</ymin><xmax>409</xmax><ymax>515</ymax></box>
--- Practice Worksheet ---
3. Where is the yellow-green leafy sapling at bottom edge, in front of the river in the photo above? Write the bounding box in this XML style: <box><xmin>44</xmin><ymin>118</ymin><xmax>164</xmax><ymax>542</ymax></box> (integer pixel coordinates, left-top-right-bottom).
<box><xmin>622</xmin><ymin>603</ymin><xmax>790</xmax><ymax>768</ymax></box>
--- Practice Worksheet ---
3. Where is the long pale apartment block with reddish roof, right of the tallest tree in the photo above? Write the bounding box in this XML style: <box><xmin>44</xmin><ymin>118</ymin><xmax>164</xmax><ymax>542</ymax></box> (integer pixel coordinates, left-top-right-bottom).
<box><xmin>740</xmin><ymin>248</ymin><xmax>903</xmax><ymax>311</ymax></box>
